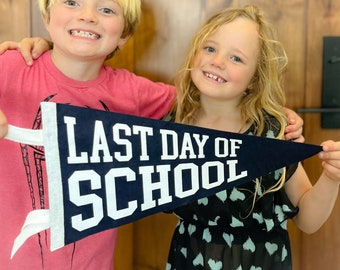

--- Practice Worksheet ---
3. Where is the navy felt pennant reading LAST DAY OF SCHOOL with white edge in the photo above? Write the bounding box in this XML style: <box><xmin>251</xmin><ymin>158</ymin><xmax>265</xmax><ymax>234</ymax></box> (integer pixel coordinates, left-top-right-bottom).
<box><xmin>8</xmin><ymin>102</ymin><xmax>322</xmax><ymax>255</ymax></box>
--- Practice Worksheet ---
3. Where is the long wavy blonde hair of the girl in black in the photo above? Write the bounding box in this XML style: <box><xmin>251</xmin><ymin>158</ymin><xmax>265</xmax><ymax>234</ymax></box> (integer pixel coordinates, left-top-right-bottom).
<box><xmin>174</xmin><ymin>5</ymin><xmax>288</xmax><ymax>196</ymax></box>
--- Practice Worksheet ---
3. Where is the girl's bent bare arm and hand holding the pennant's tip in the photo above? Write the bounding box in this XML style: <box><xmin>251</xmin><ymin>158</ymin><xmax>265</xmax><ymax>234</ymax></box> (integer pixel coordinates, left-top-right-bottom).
<box><xmin>285</xmin><ymin>141</ymin><xmax>340</xmax><ymax>233</ymax></box>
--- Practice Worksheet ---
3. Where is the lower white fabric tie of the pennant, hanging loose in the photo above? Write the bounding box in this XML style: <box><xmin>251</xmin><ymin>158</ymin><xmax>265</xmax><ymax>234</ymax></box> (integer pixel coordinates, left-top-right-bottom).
<box><xmin>11</xmin><ymin>209</ymin><xmax>50</xmax><ymax>258</ymax></box>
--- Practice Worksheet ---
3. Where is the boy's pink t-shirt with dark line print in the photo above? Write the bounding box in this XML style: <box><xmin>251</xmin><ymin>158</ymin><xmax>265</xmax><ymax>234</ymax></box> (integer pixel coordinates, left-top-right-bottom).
<box><xmin>0</xmin><ymin>51</ymin><xmax>175</xmax><ymax>270</ymax></box>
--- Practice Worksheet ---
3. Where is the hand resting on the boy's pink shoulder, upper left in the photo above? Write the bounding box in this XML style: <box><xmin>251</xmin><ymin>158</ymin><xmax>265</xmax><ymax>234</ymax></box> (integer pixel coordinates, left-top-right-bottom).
<box><xmin>0</xmin><ymin>37</ymin><xmax>53</xmax><ymax>66</ymax></box>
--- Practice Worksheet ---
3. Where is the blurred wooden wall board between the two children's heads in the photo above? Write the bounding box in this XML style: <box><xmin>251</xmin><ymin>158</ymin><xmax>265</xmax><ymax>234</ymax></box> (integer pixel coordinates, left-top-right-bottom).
<box><xmin>135</xmin><ymin>0</ymin><xmax>204</xmax><ymax>82</ymax></box>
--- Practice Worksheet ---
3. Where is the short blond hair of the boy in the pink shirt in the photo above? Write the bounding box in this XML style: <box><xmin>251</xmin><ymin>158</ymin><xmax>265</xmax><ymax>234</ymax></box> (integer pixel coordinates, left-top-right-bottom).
<box><xmin>39</xmin><ymin>0</ymin><xmax>142</xmax><ymax>59</ymax></box>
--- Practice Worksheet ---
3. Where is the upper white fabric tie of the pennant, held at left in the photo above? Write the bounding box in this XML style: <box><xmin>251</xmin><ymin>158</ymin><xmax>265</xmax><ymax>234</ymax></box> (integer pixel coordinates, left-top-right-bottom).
<box><xmin>5</xmin><ymin>125</ymin><xmax>44</xmax><ymax>146</ymax></box>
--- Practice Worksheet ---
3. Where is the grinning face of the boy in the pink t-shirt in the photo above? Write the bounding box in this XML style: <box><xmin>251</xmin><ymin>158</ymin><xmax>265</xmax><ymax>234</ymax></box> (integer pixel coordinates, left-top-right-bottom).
<box><xmin>45</xmin><ymin>0</ymin><xmax>127</xmax><ymax>59</ymax></box>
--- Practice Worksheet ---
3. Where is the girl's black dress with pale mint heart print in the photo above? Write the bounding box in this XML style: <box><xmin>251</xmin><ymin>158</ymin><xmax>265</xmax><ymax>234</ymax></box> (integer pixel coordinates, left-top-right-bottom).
<box><xmin>166</xmin><ymin>117</ymin><xmax>298</xmax><ymax>270</ymax></box>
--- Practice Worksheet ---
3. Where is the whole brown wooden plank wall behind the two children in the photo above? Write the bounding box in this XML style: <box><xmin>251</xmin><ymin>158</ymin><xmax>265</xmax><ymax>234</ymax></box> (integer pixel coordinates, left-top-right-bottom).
<box><xmin>0</xmin><ymin>0</ymin><xmax>340</xmax><ymax>270</ymax></box>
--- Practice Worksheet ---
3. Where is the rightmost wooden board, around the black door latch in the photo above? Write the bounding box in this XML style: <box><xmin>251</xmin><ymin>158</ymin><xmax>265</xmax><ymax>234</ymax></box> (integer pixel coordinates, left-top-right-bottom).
<box><xmin>300</xmin><ymin>0</ymin><xmax>340</xmax><ymax>270</ymax></box>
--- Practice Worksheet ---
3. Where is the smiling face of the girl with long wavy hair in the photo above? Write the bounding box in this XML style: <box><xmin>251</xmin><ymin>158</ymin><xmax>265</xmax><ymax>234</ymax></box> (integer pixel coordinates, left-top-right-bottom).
<box><xmin>191</xmin><ymin>17</ymin><xmax>260</xmax><ymax>102</ymax></box>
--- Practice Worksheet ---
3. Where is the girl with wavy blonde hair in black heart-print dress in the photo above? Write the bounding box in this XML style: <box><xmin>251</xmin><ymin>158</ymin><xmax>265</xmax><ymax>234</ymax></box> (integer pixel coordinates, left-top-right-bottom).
<box><xmin>167</xmin><ymin>6</ymin><xmax>340</xmax><ymax>270</ymax></box>
